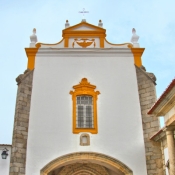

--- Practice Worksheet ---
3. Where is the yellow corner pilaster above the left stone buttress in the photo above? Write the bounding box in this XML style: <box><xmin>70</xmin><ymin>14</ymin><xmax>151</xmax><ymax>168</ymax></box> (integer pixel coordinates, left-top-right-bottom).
<box><xmin>25</xmin><ymin>48</ymin><xmax>39</xmax><ymax>70</ymax></box>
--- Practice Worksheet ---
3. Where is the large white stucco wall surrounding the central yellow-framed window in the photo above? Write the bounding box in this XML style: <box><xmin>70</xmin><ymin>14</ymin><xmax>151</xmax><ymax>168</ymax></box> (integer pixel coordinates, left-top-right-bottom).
<box><xmin>26</xmin><ymin>49</ymin><xmax>146</xmax><ymax>175</ymax></box>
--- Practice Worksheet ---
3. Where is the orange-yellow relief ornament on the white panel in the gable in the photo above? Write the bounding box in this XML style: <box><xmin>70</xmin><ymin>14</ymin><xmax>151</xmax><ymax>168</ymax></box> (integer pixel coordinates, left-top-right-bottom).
<box><xmin>72</xmin><ymin>38</ymin><xmax>96</xmax><ymax>48</ymax></box>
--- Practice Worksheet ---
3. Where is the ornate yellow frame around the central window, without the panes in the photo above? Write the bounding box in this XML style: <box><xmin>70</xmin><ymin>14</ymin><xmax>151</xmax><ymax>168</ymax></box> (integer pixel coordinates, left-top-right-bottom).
<box><xmin>70</xmin><ymin>78</ymin><xmax>100</xmax><ymax>134</ymax></box>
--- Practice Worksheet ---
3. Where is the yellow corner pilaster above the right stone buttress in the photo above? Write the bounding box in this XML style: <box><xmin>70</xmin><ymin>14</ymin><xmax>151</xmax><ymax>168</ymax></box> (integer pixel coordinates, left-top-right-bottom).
<box><xmin>131</xmin><ymin>47</ymin><xmax>145</xmax><ymax>67</ymax></box>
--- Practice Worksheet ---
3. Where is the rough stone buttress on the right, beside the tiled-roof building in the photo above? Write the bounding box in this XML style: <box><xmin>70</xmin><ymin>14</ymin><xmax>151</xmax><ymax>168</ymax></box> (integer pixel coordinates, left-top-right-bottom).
<box><xmin>136</xmin><ymin>67</ymin><xmax>163</xmax><ymax>175</ymax></box>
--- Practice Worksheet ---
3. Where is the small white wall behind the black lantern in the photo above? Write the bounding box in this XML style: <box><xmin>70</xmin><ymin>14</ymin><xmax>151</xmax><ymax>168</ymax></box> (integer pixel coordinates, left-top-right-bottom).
<box><xmin>0</xmin><ymin>145</ymin><xmax>11</xmax><ymax>175</ymax></box>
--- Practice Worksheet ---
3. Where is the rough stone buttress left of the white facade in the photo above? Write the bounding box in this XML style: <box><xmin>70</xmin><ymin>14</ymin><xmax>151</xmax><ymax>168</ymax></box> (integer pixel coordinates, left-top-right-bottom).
<box><xmin>9</xmin><ymin>71</ymin><xmax>33</xmax><ymax>175</ymax></box>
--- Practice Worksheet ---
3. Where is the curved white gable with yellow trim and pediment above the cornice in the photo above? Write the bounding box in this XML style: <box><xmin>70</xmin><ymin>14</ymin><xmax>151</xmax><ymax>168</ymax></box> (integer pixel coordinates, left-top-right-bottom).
<box><xmin>36</xmin><ymin>21</ymin><xmax>132</xmax><ymax>48</ymax></box>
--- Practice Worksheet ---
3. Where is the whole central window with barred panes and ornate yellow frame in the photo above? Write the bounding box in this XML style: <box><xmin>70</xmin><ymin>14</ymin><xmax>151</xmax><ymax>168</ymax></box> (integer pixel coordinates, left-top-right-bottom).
<box><xmin>70</xmin><ymin>78</ymin><xmax>100</xmax><ymax>134</ymax></box>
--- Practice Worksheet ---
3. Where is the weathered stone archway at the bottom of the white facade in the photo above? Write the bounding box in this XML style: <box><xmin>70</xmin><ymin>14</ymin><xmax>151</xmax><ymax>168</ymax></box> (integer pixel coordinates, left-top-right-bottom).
<box><xmin>40</xmin><ymin>152</ymin><xmax>133</xmax><ymax>175</ymax></box>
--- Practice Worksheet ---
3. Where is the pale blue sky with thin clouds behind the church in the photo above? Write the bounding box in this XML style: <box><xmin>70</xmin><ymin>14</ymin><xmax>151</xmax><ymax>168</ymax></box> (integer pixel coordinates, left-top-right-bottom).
<box><xmin>0</xmin><ymin>0</ymin><xmax>175</xmax><ymax>144</ymax></box>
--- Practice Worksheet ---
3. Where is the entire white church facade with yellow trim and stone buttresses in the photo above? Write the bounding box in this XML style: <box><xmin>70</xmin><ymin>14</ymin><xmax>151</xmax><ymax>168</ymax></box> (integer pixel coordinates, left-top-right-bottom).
<box><xmin>10</xmin><ymin>20</ymin><xmax>165</xmax><ymax>175</ymax></box>
